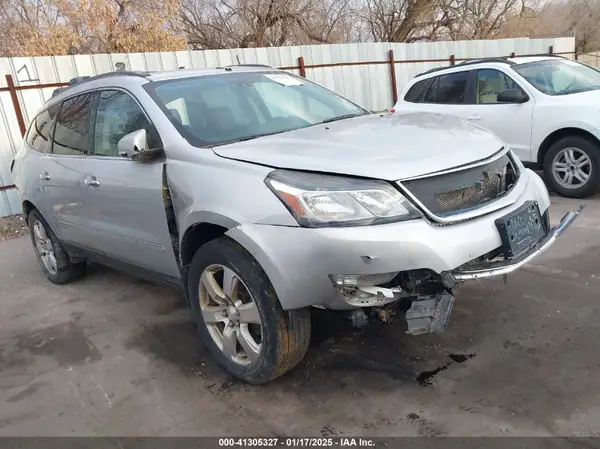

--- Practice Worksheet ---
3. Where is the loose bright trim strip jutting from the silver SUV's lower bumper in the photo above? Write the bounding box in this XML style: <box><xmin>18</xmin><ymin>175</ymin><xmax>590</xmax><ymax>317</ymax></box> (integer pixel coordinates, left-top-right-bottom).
<box><xmin>451</xmin><ymin>205</ymin><xmax>585</xmax><ymax>281</ymax></box>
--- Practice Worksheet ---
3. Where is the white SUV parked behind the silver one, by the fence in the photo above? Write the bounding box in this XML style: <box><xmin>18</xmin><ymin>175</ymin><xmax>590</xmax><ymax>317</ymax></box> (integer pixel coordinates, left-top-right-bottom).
<box><xmin>394</xmin><ymin>56</ymin><xmax>600</xmax><ymax>198</ymax></box>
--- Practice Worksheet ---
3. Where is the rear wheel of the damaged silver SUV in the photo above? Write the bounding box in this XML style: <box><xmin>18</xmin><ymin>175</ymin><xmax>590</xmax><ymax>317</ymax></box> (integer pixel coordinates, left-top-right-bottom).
<box><xmin>28</xmin><ymin>210</ymin><xmax>87</xmax><ymax>285</ymax></box>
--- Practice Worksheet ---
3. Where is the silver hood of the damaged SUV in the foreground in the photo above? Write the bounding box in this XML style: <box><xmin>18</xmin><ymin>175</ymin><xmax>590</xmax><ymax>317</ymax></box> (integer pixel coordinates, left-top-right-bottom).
<box><xmin>213</xmin><ymin>113</ymin><xmax>503</xmax><ymax>181</ymax></box>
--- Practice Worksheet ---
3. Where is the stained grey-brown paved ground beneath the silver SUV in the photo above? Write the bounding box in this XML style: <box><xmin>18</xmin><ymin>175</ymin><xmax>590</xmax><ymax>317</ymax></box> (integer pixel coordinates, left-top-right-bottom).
<box><xmin>0</xmin><ymin>197</ymin><xmax>600</xmax><ymax>436</ymax></box>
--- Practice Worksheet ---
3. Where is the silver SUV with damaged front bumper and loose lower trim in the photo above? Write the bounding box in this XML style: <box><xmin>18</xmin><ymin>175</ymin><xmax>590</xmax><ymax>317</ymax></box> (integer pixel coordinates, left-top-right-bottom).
<box><xmin>12</xmin><ymin>66</ymin><xmax>578</xmax><ymax>383</ymax></box>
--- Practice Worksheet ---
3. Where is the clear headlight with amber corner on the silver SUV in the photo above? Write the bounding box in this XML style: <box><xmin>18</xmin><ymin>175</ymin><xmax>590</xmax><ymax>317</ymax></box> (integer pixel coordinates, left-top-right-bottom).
<box><xmin>265</xmin><ymin>170</ymin><xmax>421</xmax><ymax>228</ymax></box>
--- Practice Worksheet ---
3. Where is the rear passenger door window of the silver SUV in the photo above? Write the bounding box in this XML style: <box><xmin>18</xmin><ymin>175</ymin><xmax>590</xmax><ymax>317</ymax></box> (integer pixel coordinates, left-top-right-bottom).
<box><xmin>52</xmin><ymin>94</ymin><xmax>93</xmax><ymax>156</ymax></box>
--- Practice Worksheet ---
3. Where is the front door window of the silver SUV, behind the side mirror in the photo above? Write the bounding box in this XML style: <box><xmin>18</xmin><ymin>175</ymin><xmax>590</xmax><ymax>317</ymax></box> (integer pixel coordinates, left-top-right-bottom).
<box><xmin>94</xmin><ymin>90</ymin><xmax>160</xmax><ymax>157</ymax></box>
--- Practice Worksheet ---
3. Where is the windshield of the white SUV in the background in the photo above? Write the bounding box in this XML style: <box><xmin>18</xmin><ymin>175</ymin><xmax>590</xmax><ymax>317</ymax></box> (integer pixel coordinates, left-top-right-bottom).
<box><xmin>511</xmin><ymin>59</ymin><xmax>600</xmax><ymax>95</ymax></box>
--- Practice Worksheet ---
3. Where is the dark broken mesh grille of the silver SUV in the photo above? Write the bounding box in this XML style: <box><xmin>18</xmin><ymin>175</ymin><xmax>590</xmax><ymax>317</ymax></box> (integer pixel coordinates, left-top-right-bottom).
<box><xmin>401</xmin><ymin>153</ymin><xmax>519</xmax><ymax>216</ymax></box>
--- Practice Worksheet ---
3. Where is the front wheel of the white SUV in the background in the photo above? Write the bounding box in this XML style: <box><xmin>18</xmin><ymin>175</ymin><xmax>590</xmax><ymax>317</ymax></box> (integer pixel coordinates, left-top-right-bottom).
<box><xmin>544</xmin><ymin>136</ymin><xmax>600</xmax><ymax>198</ymax></box>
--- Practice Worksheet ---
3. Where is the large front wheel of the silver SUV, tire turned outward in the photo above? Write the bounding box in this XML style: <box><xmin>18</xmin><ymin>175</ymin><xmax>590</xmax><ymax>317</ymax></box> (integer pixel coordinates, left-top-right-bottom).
<box><xmin>188</xmin><ymin>237</ymin><xmax>310</xmax><ymax>384</ymax></box>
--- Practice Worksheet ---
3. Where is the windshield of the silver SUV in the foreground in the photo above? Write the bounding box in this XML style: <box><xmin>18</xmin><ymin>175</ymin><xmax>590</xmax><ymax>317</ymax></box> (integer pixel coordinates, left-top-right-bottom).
<box><xmin>144</xmin><ymin>72</ymin><xmax>369</xmax><ymax>147</ymax></box>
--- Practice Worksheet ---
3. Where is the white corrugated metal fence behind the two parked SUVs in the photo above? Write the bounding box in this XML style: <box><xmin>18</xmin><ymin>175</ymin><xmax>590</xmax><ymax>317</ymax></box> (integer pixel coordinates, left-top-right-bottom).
<box><xmin>0</xmin><ymin>37</ymin><xmax>575</xmax><ymax>216</ymax></box>
